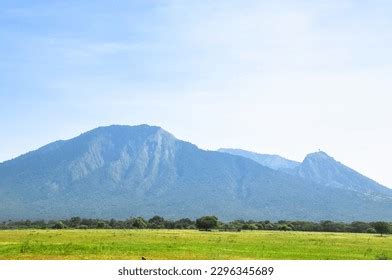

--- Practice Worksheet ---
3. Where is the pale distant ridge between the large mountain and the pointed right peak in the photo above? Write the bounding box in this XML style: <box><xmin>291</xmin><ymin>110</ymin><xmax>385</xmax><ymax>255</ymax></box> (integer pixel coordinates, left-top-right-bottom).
<box><xmin>218</xmin><ymin>149</ymin><xmax>300</xmax><ymax>170</ymax></box>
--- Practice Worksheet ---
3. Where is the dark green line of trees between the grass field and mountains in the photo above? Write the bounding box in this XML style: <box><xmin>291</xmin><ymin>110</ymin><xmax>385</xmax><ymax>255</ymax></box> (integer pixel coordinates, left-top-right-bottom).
<box><xmin>0</xmin><ymin>216</ymin><xmax>392</xmax><ymax>234</ymax></box>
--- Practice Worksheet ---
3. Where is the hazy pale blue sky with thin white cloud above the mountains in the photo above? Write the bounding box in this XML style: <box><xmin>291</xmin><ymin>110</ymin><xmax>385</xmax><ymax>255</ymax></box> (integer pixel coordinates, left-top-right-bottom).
<box><xmin>0</xmin><ymin>0</ymin><xmax>392</xmax><ymax>187</ymax></box>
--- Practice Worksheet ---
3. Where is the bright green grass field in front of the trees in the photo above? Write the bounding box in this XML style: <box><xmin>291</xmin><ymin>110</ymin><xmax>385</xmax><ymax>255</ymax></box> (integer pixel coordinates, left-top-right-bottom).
<box><xmin>0</xmin><ymin>230</ymin><xmax>392</xmax><ymax>260</ymax></box>
